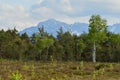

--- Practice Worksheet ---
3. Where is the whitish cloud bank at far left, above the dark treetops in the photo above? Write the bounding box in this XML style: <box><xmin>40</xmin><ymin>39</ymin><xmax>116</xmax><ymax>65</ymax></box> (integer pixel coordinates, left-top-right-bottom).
<box><xmin>0</xmin><ymin>4</ymin><xmax>34</xmax><ymax>30</ymax></box>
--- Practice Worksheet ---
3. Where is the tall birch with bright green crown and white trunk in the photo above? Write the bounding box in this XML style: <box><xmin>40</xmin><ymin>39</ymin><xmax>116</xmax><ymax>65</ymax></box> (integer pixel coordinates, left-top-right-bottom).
<box><xmin>88</xmin><ymin>15</ymin><xmax>107</xmax><ymax>63</ymax></box>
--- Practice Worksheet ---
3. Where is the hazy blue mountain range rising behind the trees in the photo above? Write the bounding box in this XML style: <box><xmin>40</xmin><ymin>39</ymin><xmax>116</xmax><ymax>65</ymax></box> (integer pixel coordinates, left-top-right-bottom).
<box><xmin>19</xmin><ymin>19</ymin><xmax>120</xmax><ymax>36</ymax></box>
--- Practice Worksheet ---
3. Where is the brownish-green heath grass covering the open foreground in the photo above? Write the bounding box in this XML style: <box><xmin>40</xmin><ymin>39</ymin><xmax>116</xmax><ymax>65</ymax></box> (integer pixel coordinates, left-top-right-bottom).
<box><xmin>0</xmin><ymin>60</ymin><xmax>120</xmax><ymax>80</ymax></box>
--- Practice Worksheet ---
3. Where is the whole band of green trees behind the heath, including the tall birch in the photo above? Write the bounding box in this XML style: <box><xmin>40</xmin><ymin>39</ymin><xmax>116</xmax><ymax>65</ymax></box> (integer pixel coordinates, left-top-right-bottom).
<box><xmin>0</xmin><ymin>15</ymin><xmax>120</xmax><ymax>62</ymax></box>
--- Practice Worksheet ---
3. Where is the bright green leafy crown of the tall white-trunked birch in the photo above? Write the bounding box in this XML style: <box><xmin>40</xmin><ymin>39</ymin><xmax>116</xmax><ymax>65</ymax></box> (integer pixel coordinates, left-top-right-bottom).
<box><xmin>89</xmin><ymin>15</ymin><xmax>107</xmax><ymax>41</ymax></box>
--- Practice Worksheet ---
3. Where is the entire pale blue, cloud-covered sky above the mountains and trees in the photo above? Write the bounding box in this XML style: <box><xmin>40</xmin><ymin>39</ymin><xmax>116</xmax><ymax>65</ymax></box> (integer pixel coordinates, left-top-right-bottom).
<box><xmin>0</xmin><ymin>0</ymin><xmax>120</xmax><ymax>31</ymax></box>
